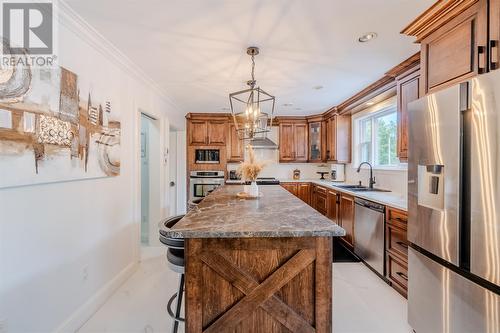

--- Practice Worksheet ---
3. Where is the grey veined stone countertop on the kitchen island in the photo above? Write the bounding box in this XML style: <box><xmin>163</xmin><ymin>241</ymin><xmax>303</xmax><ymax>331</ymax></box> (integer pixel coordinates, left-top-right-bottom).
<box><xmin>159</xmin><ymin>185</ymin><xmax>345</xmax><ymax>238</ymax></box>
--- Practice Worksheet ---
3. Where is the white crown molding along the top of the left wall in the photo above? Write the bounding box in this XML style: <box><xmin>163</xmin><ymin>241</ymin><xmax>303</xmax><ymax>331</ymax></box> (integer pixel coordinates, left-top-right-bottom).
<box><xmin>56</xmin><ymin>0</ymin><xmax>182</xmax><ymax>111</ymax></box>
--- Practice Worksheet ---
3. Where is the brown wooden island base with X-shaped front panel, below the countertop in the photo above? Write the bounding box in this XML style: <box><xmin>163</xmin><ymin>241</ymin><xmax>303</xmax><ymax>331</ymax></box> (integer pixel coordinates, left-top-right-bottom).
<box><xmin>185</xmin><ymin>237</ymin><xmax>332</xmax><ymax>333</ymax></box>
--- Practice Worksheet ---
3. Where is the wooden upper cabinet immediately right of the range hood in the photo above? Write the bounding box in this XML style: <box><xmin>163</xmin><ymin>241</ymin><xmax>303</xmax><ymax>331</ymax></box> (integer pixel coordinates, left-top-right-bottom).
<box><xmin>279</xmin><ymin>122</ymin><xmax>308</xmax><ymax>162</ymax></box>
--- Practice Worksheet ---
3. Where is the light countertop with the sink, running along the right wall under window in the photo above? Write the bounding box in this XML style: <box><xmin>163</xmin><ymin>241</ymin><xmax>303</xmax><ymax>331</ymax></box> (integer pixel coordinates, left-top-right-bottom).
<box><xmin>279</xmin><ymin>179</ymin><xmax>408</xmax><ymax>211</ymax></box>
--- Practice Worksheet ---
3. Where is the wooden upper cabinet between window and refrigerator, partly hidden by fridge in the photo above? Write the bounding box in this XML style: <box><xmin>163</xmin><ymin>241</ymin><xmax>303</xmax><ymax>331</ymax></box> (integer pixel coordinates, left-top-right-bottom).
<box><xmin>397</xmin><ymin>68</ymin><xmax>420</xmax><ymax>161</ymax></box>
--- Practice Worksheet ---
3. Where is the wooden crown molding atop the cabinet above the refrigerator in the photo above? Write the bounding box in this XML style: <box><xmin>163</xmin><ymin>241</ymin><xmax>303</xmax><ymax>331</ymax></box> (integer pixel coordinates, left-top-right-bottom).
<box><xmin>401</xmin><ymin>0</ymin><xmax>479</xmax><ymax>43</ymax></box>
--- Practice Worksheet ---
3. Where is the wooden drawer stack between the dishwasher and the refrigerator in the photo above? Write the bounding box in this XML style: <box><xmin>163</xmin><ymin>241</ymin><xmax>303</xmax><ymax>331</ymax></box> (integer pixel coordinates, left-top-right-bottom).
<box><xmin>385</xmin><ymin>207</ymin><xmax>409</xmax><ymax>297</ymax></box>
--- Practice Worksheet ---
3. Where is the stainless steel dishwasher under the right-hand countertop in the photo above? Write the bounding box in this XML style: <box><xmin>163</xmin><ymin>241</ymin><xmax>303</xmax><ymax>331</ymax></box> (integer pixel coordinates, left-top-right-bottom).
<box><xmin>354</xmin><ymin>198</ymin><xmax>385</xmax><ymax>276</ymax></box>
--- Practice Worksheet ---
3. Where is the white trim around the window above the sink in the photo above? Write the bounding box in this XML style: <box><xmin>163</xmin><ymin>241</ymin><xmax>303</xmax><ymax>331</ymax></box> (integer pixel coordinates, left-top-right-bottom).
<box><xmin>351</xmin><ymin>96</ymin><xmax>408</xmax><ymax>171</ymax></box>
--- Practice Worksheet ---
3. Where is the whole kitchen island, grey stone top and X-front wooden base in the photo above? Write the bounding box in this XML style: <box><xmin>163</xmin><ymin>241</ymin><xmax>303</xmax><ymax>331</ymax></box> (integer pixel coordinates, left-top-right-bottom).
<box><xmin>165</xmin><ymin>185</ymin><xmax>345</xmax><ymax>333</ymax></box>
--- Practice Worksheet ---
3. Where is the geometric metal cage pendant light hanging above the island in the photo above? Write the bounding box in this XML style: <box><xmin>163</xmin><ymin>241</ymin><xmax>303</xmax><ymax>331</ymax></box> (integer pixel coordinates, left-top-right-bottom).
<box><xmin>229</xmin><ymin>46</ymin><xmax>275</xmax><ymax>140</ymax></box>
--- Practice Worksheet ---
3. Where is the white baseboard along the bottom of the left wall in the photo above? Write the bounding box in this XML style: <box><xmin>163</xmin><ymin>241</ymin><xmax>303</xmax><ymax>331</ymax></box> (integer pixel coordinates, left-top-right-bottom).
<box><xmin>55</xmin><ymin>262</ymin><xmax>138</xmax><ymax>333</ymax></box>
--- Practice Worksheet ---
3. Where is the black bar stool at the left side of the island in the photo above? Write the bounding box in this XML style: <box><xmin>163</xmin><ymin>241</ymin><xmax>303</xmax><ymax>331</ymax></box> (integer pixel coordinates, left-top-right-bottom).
<box><xmin>159</xmin><ymin>215</ymin><xmax>184</xmax><ymax>333</ymax></box>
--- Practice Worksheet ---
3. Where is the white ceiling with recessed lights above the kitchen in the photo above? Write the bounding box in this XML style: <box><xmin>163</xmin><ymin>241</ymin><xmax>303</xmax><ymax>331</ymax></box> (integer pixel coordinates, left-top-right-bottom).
<box><xmin>66</xmin><ymin>0</ymin><xmax>434</xmax><ymax>115</ymax></box>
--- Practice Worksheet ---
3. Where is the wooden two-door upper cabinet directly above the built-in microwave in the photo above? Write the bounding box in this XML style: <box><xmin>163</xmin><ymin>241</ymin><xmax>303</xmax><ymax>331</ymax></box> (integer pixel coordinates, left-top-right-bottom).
<box><xmin>188</xmin><ymin>118</ymin><xmax>228</xmax><ymax>146</ymax></box>
